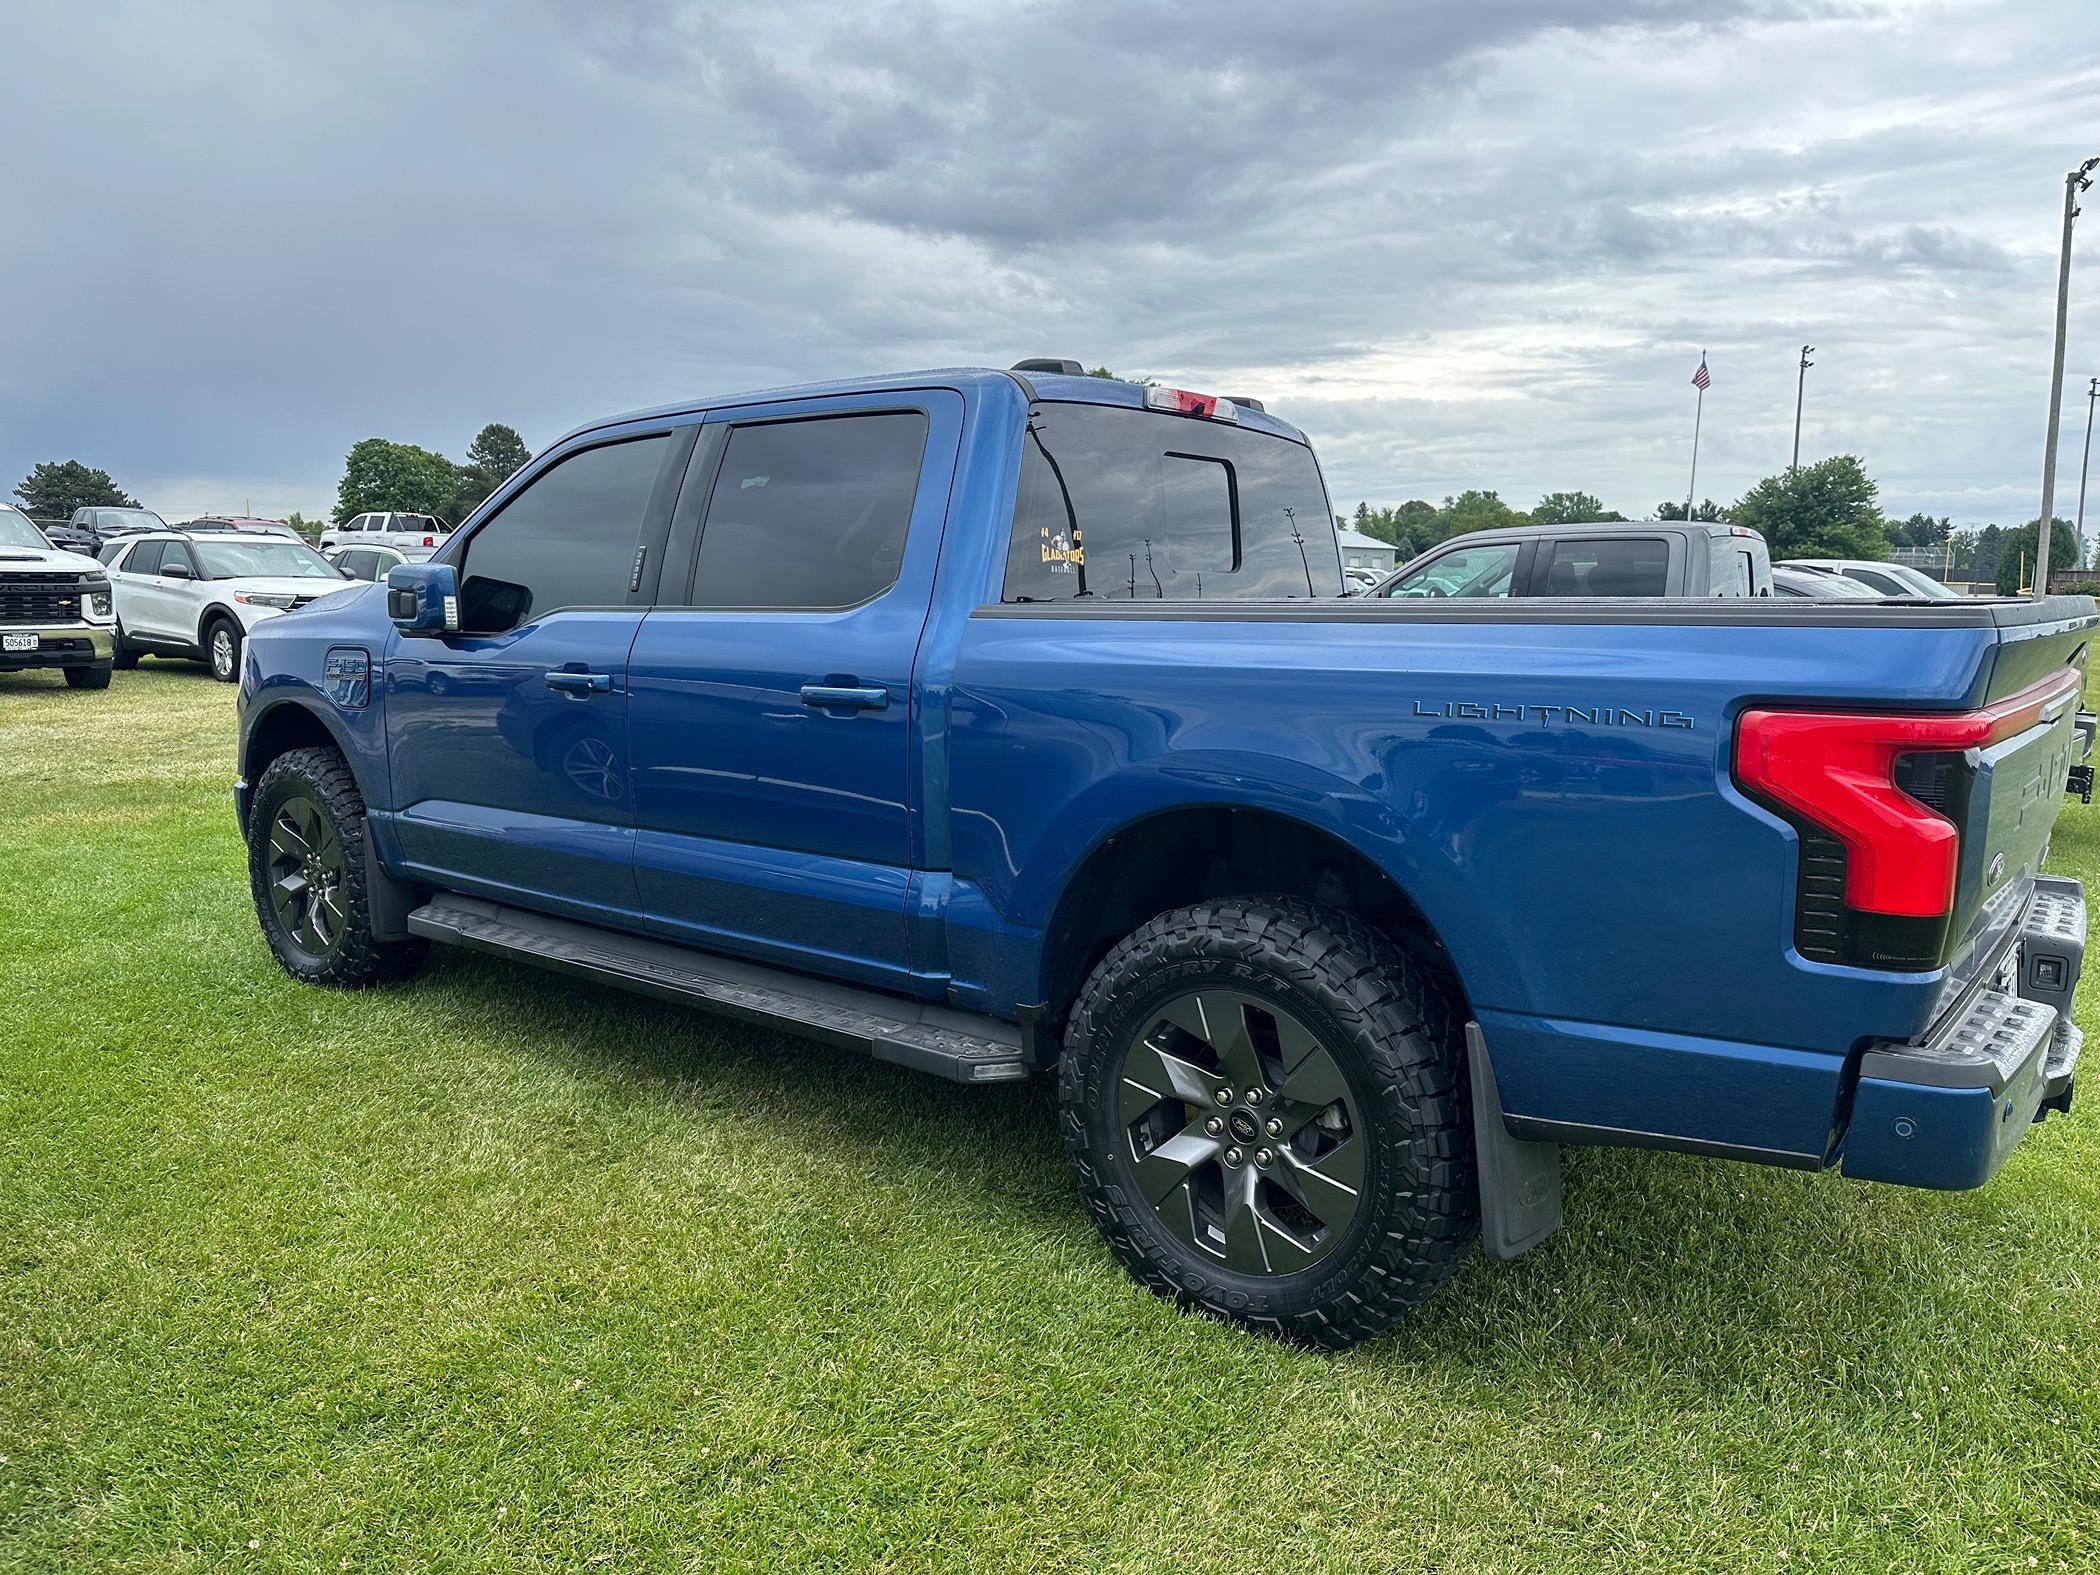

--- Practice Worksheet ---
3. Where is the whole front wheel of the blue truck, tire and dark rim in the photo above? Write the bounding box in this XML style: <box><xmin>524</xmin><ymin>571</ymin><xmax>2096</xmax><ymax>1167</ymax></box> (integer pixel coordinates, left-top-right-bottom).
<box><xmin>248</xmin><ymin>750</ymin><xmax>428</xmax><ymax>989</ymax></box>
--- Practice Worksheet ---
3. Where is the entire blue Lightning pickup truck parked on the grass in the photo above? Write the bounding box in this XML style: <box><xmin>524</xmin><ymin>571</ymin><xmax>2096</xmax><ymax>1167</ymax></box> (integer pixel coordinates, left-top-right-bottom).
<box><xmin>235</xmin><ymin>361</ymin><xmax>2100</xmax><ymax>1346</ymax></box>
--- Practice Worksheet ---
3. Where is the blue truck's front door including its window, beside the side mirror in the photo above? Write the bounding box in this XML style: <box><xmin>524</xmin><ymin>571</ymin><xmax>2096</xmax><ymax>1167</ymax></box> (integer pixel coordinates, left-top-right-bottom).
<box><xmin>386</xmin><ymin>426</ymin><xmax>693</xmax><ymax>918</ymax></box>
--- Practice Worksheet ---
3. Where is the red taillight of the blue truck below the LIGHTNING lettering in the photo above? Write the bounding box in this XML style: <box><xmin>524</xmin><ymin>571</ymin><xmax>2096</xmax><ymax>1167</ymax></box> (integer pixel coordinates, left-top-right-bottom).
<box><xmin>1735</xmin><ymin>670</ymin><xmax>2079</xmax><ymax>918</ymax></box>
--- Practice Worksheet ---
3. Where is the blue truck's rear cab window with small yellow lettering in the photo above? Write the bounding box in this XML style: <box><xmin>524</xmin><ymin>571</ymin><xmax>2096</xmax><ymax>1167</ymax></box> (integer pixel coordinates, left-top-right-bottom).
<box><xmin>1004</xmin><ymin>403</ymin><xmax>1342</xmax><ymax>601</ymax></box>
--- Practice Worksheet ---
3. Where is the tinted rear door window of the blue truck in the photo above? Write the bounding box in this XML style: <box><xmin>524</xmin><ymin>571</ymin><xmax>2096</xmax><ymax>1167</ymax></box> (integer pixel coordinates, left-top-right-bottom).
<box><xmin>691</xmin><ymin>410</ymin><xmax>926</xmax><ymax>609</ymax></box>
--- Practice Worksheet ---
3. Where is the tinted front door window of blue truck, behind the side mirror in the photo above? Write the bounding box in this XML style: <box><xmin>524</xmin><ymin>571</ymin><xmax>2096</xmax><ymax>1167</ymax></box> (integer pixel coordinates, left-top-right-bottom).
<box><xmin>460</xmin><ymin>435</ymin><xmax>670</xmax><ymax>634</ymax></box>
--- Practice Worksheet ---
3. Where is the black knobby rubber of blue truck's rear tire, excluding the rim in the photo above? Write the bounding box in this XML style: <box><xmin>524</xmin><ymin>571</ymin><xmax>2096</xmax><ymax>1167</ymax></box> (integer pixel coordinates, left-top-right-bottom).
<box><xmin>1058</xmin><ymin>897</ymin><xmax>1481</xmax><ymax>1350</ymax></box>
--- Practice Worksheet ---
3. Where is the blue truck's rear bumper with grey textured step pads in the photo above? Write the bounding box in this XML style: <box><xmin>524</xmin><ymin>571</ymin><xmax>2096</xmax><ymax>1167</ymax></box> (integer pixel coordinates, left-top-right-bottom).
<box><xmin>1842</xmin><ymin>876</ymin><xmax>2085</xmax><ymax>1189</ymax></box>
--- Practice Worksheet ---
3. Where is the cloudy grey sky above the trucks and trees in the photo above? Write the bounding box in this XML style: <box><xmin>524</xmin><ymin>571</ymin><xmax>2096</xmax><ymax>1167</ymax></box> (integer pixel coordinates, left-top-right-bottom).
<box><xmin>0</xmin><ymin>0</ymin><xmax>2100</xmax><ymax>531</ymax></box>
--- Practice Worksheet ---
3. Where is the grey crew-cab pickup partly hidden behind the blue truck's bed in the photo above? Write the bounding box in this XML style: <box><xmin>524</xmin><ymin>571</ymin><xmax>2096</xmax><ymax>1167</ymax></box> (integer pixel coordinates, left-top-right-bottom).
<box><xmin>1369</xmin><ymin>519</ymin><xmax>1772</xmax><ymax>599</ymax></box>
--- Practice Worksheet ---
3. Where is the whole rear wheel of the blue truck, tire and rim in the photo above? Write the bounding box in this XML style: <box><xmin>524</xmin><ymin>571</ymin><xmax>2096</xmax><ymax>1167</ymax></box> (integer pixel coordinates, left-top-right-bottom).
<box><xmin>1058</xmin><ymin>897</ymin><xmax>1478</xmax><ymax>1348</ymax></box>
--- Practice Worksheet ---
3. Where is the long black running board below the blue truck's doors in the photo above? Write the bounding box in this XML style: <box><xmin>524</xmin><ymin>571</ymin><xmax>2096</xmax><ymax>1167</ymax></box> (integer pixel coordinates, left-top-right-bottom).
<box><xmin>407</xmin><ymin>897</ymin><xmax>1029</xmax><ymax>1084</ymax></box>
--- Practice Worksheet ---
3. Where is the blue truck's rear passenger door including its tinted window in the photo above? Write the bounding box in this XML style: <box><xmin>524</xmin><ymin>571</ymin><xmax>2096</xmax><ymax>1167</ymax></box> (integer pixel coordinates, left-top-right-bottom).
<box><xmin>630</xmin><ymin>391</ymin><xmax>962</xmax><ymax>987</ymax></box>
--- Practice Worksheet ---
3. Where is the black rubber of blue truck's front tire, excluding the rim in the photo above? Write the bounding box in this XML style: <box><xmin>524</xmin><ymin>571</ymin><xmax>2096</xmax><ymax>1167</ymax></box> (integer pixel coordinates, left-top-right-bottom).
<box><xmin>248</xmin><ymin>748</ymin><xmax>428</xmax><ymax>989</ymax></box>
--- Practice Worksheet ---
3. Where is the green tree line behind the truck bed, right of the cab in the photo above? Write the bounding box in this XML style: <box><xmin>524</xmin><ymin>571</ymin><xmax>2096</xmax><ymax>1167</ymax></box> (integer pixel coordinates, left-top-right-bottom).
<box><xmin>1336</xmin><ymin>454</ymin><xmax>2085</xmax><ymax>594</ymax></box>
